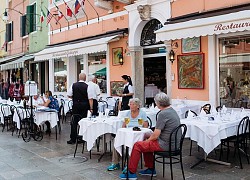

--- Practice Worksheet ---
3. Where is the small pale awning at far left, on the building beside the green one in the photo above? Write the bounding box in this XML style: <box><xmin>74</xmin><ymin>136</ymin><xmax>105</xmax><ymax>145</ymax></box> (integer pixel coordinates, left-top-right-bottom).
<box><xmin>1</xmin><ymin>54</ymin><xmax>34</xmax><ymax>70</ymax></box>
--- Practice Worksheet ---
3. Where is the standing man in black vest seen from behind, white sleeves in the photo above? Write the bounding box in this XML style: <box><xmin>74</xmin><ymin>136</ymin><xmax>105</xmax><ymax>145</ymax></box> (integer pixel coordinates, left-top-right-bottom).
<box><xmin>67</xmin><ymin>73</ymin><xmax>95</xmax><ymax>144</ymax></box>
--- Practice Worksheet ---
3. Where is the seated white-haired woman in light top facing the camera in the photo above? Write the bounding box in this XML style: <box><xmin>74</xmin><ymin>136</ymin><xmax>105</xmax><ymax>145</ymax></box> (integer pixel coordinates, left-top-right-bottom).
<box><xmin>107</xmin><ymin>98</ymin><xmax>148</xmax><ymax>171</ymax></box>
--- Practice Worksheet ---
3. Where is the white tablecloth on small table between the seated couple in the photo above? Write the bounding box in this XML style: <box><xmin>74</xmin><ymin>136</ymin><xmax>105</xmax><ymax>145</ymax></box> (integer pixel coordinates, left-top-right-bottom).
<box><xmin>114</xmin><ymin>128</ymin><xmax>153</xmax><ymax>155</ymax></box>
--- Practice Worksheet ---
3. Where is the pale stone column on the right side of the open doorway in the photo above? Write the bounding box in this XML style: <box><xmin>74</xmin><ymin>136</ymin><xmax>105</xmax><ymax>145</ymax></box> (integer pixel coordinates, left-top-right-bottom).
<box><xmin>164</xmin><ymin>41</ymin><xmax>172</xmax><ymax>99</ymax></box>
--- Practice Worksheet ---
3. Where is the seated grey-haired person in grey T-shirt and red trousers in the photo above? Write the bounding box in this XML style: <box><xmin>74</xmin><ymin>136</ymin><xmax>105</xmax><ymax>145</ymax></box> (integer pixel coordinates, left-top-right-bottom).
<box><xmin>120</xmin><ymin>93</ymin><xmax>180</xmax><ymax>179</ymax></box>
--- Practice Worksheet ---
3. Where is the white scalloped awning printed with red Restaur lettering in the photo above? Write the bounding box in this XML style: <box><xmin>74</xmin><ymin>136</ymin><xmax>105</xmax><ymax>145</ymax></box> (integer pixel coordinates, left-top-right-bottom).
<box><xmin>155</xmin><ymin>10</ymin><xmax>250</xmax><ymax>41</ymax></box>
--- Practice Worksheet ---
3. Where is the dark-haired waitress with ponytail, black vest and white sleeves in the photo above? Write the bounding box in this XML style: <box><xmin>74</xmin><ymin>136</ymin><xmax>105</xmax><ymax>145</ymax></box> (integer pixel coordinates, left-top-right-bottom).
<box><xmin>119</xmin><ymin>75</ymin><xmax>134</xmax><ymax>110</ymax></box>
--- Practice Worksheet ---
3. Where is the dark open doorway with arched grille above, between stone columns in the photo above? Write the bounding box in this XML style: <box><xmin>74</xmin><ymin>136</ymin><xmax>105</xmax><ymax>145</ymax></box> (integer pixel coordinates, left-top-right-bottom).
<box><xmin>140</xmin><ymin>19</ymin><xmax>167</xmax><ymax>105</ymax></box>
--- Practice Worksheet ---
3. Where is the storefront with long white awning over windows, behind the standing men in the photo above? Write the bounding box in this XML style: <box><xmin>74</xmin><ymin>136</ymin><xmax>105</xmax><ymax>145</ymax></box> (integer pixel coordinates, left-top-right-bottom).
<box><xmin>35</xmin><ymin>29</ymin><xmax>128</xmax><ymax>95</ymax></box>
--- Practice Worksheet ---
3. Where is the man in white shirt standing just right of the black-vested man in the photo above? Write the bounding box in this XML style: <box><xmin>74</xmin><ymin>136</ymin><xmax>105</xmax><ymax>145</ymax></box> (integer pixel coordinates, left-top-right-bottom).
<box><xmin>88</xmin><ymin>75</ymin><xmax>101</xmax><ymax>116</ymax></box>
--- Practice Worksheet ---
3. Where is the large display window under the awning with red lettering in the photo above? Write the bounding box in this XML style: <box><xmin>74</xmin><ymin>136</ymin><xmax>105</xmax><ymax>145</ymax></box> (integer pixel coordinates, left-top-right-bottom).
<box><xmin>219</xmin><ymin>35</ymin><xmax>250</xmax><ymax>108</ymax></box>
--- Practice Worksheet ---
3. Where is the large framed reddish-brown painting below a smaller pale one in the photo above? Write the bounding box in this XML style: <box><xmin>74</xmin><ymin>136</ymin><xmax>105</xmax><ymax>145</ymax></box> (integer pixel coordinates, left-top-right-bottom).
<box><xmin>177</xmin><ymin>53</ymin><xmax>205</xmax><ymax>89</ymax></box>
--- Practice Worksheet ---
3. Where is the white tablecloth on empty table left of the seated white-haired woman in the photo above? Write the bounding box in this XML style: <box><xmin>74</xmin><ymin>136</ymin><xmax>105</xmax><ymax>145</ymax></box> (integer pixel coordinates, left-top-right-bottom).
<box><xmin>78</xmin><ymin>117</ymin><xmax>123</xmax><ymax>151</ymax></box>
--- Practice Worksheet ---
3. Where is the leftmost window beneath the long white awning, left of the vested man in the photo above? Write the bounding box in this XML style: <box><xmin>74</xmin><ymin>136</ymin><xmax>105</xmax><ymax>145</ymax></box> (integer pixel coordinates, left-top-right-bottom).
<box><xmin>54</xmin><ymin>58</ymin><xmax>68</xmax><ymax>92</ymax></box>
